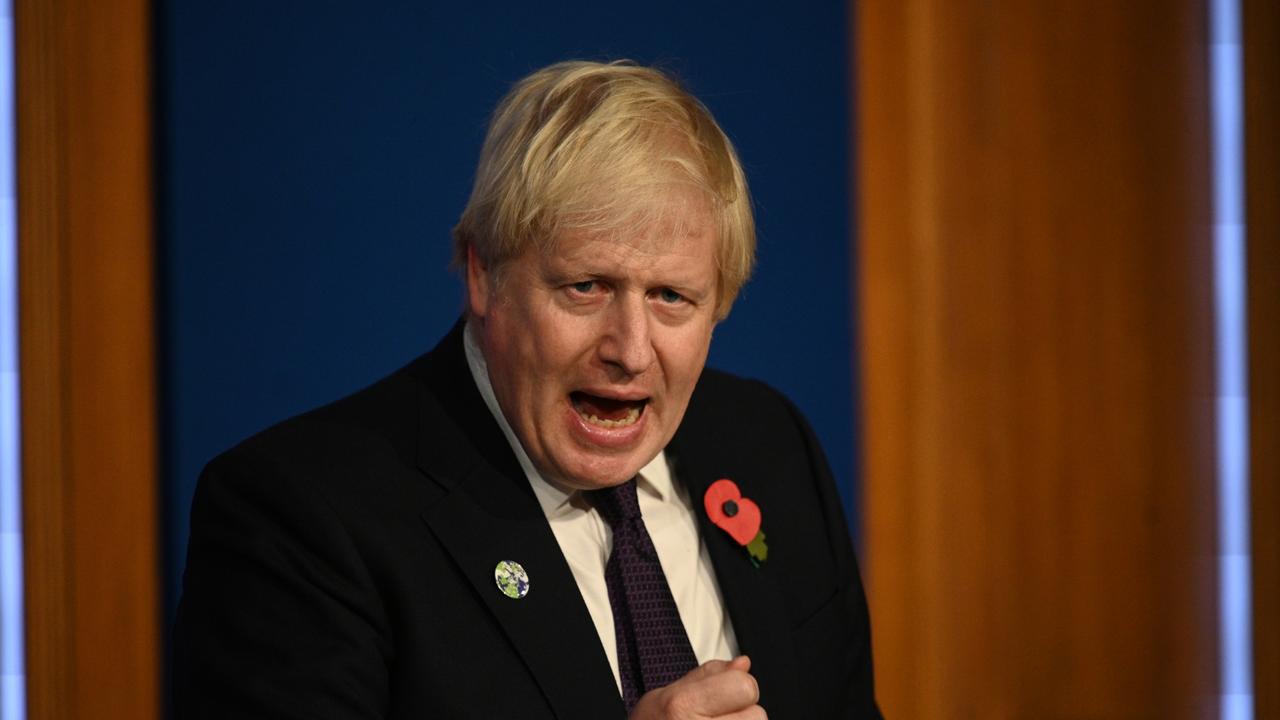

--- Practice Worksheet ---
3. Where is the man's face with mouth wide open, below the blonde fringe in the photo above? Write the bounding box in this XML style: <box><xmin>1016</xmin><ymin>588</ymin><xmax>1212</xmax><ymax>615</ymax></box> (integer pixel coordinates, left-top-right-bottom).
<box><xmin>467</xmin><ymin>204</ymin><xmax>718</xmax><ymax>489</ymax></box>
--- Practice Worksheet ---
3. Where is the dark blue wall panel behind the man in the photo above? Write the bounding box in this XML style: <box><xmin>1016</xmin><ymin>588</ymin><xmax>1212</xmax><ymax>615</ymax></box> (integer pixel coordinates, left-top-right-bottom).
<box><xmin>156</xmin><ymin>0</ymin><xmax>855</xmax><ymax>607</ymax></box>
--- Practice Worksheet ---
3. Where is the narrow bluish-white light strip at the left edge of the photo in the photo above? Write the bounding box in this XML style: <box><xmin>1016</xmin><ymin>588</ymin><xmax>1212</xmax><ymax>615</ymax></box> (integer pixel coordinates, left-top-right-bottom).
<box><xmin>0</xmin><ymin>0</ymin><xmax>27</xmax><ymax>720</ymax></box>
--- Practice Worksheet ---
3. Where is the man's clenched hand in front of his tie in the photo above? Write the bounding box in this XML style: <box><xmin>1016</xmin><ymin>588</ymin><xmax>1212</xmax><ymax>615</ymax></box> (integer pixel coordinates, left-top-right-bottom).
<box><xmin>630</xmin><ymin>655</ymin><xmax>767</xmax><ymax>720</ymax></box>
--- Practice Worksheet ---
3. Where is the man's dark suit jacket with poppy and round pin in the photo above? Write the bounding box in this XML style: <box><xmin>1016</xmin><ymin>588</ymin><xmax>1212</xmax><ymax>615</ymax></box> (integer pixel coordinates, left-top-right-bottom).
<box><xmin>173</xmin><ymin>325</ymin><xmax>878</xmax><ymax>720</ymax></box>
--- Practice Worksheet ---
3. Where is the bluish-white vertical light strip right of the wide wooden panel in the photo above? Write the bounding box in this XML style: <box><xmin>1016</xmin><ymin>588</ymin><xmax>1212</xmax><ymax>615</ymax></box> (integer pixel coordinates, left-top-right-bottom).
<box><xmin>1208</xmin><ymin>0</ymin><xmax>1253</xmax><ymax>720</ymax></box>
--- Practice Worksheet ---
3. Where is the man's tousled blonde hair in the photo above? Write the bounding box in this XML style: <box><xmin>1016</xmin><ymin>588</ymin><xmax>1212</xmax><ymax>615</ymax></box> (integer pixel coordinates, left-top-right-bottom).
<box><xmin>453</xmin><ymin>60</ymin><xmax>755</xmax><ymax>319</ymax></box>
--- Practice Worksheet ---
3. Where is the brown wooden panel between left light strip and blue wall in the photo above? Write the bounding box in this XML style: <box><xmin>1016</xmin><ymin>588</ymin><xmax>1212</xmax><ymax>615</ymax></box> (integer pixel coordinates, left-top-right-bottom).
<box><xmin>14</xmin><ymin>0</ymin><xmax>160</xmax><ymax>719</ymax></box>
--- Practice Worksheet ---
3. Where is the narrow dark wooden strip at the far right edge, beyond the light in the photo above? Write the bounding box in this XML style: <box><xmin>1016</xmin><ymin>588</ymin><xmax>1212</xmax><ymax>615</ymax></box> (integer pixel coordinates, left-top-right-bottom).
<box><xmin>1242</xmin><ymin>0</ymin><xmax>1280</xmax><ymax>719</ymax></box>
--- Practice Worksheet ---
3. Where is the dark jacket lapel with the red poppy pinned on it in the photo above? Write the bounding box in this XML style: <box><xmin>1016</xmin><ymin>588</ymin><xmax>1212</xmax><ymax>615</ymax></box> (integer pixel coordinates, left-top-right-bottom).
<box><xmin>667</xmin><ymin>425</ymin><xmax>797</xmax><ymax>717</ymax></box>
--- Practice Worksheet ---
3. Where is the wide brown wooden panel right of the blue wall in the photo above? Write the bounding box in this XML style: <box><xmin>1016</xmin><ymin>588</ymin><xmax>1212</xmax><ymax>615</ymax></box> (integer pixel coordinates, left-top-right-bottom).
<box><xmin>855</xmin><ymin>0</ymin><xmax>1217</xmax><ymax>719</ymax></box>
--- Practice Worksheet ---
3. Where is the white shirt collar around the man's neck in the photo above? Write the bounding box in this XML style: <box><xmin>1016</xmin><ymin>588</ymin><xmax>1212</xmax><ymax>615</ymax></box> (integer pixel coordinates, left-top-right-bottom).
<box><xmin>462</xmin><ymin>318</ymin><xmax>675</xmax><ymax>519</ymax></box>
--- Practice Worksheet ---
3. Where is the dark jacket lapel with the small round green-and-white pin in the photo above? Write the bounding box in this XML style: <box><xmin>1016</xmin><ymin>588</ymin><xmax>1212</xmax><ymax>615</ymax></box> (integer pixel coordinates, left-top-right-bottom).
<box><xmin>415</xmin><ymin>323</ymin><xmax>625</xmax><ymax>719</ymax></box>
